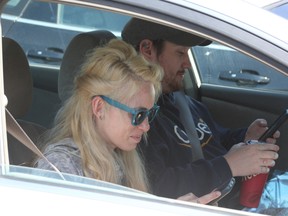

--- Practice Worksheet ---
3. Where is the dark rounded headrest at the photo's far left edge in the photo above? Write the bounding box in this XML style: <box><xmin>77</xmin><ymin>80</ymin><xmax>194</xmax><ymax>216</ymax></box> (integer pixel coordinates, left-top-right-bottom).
<box><xmin>2</xmin><ymin>37</ymin><xmax>33</xmax><ymax>118</ymax></box>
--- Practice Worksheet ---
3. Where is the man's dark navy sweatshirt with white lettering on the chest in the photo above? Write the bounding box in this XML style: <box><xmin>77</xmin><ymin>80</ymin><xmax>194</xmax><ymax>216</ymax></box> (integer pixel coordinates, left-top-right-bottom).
<box><xmin>141</xmin><ymin>93</ymin><xmax>246</xmax><ymax>201</ymax></box>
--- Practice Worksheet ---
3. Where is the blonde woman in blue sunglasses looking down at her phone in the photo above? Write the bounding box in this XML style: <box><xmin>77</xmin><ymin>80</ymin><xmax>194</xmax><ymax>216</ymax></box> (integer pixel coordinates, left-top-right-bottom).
<box><xmin>35</xmin><ymin>39</ymin><xmax>217</xmax><ymax>202</ymax></box>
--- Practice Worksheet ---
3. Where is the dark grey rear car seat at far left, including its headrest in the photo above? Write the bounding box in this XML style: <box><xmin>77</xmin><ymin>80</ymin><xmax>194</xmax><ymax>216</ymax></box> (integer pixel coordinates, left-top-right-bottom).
<box><xmin>2</xmin><ymin>37</ymin><xmax>46</xmax><ymax>166</ymax></box>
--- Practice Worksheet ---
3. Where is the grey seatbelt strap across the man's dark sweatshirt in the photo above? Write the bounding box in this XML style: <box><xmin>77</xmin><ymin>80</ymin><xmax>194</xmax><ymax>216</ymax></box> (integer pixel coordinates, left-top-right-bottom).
<box><xmin>174</xmin><ymin>91</ymin><xmax>204</xmax><ymax>161</ymax></box>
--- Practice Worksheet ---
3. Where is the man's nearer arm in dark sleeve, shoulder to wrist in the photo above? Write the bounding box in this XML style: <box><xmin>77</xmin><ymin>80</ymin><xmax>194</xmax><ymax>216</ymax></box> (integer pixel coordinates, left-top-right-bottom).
<box><xmin>141</xmin><ymin>120</ymin><xmax>232</xmax><ymax>198</ymax></box>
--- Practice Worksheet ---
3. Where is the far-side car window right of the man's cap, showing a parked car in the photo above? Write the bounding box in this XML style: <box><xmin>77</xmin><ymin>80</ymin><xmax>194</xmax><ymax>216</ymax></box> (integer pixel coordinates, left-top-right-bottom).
<box><xmin>192</xmin><ymin>42</ymin><xmax>288</xmax><ymax>91</ymax></box>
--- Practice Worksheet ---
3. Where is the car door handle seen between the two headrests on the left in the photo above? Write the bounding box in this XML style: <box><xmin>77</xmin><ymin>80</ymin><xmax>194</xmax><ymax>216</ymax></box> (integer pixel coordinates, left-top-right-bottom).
<box><xmin>27</xmin><ymin>47</ymin><xmax>64</xmax><ymax>62</ymax></box>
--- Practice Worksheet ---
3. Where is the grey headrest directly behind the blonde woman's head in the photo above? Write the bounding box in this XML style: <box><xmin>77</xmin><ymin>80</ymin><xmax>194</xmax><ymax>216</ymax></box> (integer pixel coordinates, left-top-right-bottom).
<box><xmin>58</xmin><ymin>30</ymin><xmax>116</xmax><ymax>102</ymax></box>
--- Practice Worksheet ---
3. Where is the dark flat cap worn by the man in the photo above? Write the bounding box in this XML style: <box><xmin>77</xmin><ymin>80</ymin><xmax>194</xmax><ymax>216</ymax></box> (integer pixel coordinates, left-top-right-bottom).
<box><xmin>122</xmin><ymin>18</ymin><xmax>212</xmax><ymax>47</ymax></box>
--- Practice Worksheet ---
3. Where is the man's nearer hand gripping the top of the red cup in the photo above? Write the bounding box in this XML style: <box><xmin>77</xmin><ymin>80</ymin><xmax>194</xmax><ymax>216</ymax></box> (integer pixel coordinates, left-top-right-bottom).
<box><xmin>224</xmin><ymin>143</ymin><xmax>279</xmax><ymax>177</ymax></box>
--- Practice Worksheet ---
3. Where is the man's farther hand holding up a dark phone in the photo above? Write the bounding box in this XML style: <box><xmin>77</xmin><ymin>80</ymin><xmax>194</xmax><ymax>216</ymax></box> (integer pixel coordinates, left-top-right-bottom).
<box><xmin>244</xmin><ymin>119</ymin><xmax>280</xmax><ymax>144</ymax></box>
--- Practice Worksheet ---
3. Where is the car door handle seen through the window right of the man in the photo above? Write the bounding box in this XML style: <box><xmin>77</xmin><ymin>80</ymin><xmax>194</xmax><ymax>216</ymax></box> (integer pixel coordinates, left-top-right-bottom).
<box><xmin>219</xmin><ymin>69</ymin><xmax>270</xmax><ymax>85</ymax></box>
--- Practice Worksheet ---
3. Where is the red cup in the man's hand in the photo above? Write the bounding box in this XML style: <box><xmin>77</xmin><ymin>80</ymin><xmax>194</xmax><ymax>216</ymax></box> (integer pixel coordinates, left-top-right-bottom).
<box><xmin>240</xmin><ymin>173</ymin><xmax>268</xmax><ymax>208</ymax></box>
